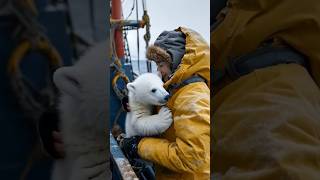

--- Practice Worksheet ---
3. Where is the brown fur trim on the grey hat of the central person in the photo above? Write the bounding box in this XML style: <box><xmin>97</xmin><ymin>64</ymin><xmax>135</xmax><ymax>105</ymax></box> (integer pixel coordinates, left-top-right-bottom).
<box><xmin>146</xmin><ymin>45</ymin><xmax>172</xmax><ymax>63</ymax></box>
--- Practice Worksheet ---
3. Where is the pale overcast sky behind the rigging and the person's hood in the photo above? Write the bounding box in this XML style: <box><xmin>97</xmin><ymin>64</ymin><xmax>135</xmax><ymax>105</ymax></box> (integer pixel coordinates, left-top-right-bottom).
<box><xmin>122</xmin><ymin>0</ymin><xmax>210</xmax><ymax>59</ymax></box>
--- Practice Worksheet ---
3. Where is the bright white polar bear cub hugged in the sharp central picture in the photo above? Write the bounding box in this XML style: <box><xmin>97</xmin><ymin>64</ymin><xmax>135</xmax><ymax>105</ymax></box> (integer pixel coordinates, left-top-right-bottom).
<box><xmin>125</xmin><ymin>73</ymin><xmax>172</xmax><ymax>137</ymax></box>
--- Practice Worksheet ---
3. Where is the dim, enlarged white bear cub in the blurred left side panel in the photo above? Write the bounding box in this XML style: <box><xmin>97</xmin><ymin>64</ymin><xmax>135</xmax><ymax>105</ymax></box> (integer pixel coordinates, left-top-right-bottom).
<box><xmin>52</xmin><ymin>42</ymin><xmax>111</xmax><ymax>180</ymax></box>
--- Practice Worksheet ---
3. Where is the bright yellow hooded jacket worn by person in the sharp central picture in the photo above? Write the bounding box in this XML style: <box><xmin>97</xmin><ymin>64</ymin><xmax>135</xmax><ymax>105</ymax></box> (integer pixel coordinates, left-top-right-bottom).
<box><xmin>138</xmin><ymin>27</ymin><xmax>210</xmax><ymax>180</ymax></box>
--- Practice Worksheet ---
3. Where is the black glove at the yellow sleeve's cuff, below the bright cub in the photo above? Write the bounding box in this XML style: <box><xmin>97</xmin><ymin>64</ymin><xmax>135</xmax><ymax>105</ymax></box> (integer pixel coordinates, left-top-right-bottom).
<box><xmin>120</xmin><ymin>136</ymin><xmax>142</xmax><ymax>159</ymax></box>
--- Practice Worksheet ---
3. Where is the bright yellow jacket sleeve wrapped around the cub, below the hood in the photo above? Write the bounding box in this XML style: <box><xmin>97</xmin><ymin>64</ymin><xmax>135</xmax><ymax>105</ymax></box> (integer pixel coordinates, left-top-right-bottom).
<box><xmin>138</xmin><ymin>83</ymin><xmax>210</xmax><ymax>173</ymax></box>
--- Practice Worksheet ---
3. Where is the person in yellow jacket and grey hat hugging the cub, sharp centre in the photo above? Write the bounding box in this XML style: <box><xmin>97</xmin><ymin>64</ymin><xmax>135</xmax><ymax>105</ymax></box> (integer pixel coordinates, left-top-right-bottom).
<box><xmin>120</xmin><ymin>27</ymin><xmax>210</xmax><ymax>180</ymax></box>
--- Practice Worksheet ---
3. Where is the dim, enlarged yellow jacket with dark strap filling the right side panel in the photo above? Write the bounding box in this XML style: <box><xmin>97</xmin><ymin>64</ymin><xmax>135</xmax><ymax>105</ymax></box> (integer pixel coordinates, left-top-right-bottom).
<box><xmin>211</xmin><ymin>0</ymin><xmax>320</xmax><ymax>180</ymax></box>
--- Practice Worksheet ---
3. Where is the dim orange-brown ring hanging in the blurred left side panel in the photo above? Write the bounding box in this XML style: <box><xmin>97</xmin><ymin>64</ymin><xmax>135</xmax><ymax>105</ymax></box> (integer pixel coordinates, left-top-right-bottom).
<box><xmin>7</xmin><ymin>40</ymin><xmax>62</xmax><ymax>123</ymax></box>
